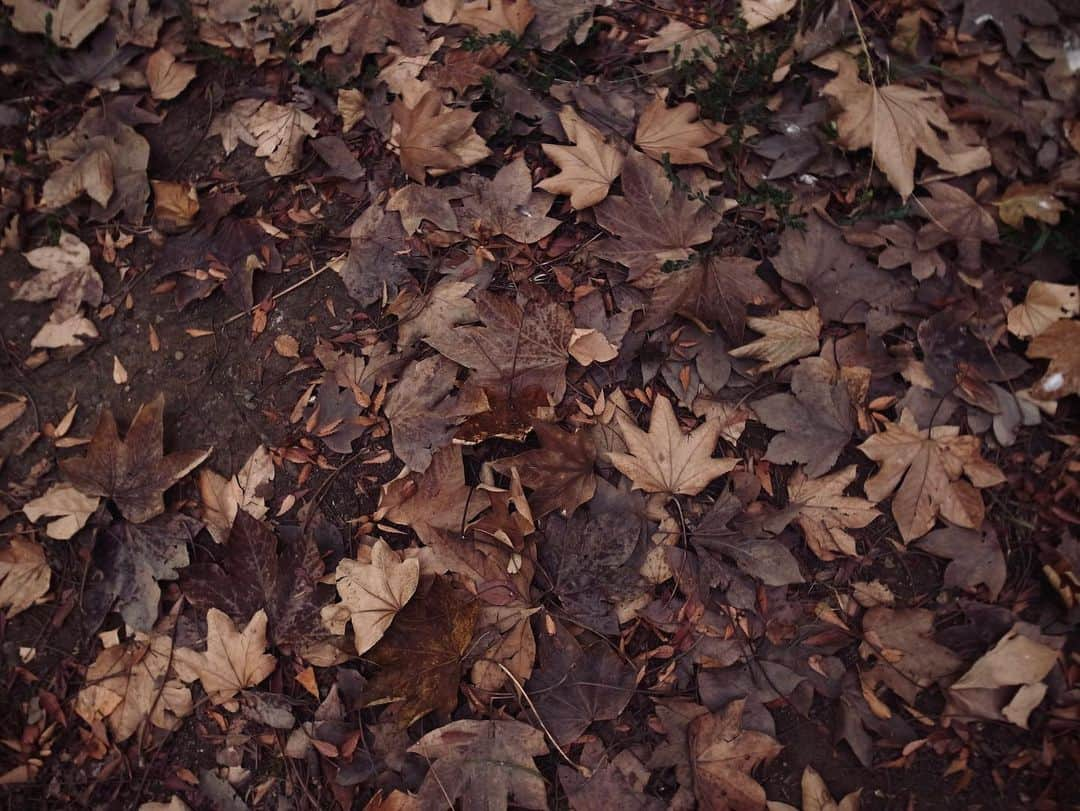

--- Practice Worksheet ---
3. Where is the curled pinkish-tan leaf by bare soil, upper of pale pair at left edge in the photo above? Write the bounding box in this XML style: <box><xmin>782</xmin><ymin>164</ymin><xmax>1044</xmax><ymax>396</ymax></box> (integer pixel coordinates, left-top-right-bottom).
<box><xmin>12</xmin><ymin>232</ymin><xmax>104</xmax><ymax>321</ymax></box>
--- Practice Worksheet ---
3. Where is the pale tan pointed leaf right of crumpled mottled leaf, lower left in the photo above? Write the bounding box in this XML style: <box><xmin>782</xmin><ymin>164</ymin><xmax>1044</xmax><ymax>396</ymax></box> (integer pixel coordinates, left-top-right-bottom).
<box><xmin>173</xmin><ymin>608</ymin><xmax>278</xmax><ymax>704</ymax></box>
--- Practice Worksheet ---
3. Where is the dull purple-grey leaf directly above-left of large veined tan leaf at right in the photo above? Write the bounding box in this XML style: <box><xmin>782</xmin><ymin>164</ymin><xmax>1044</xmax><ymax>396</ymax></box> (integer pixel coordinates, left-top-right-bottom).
<box><xmin>752</xmin><ymin>357</ymin><xmax>855</xmax><ymax>477</ymax></box>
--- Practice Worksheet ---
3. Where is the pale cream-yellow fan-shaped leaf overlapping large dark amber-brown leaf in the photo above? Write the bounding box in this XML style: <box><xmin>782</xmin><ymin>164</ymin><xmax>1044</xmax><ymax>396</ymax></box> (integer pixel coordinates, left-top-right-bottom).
<box><xmin>323</xmin><ymin>540</ymin><xmax>420</xmax><ymax>654</ymax></box>
